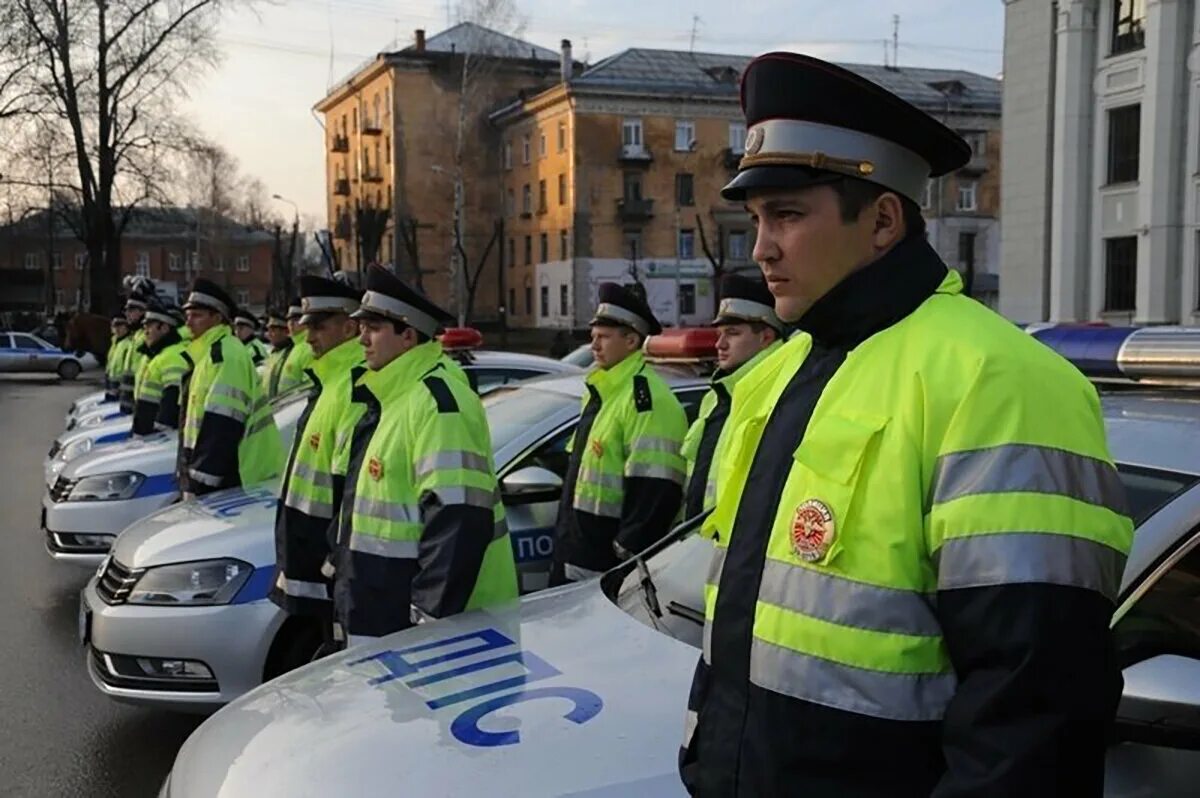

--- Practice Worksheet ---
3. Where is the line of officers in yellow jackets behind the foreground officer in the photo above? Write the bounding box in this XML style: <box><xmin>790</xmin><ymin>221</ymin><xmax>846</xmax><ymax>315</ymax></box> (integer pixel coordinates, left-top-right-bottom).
<box><xmin>98</xmin><ymin>268</ymin><xmax>763</xmax><ymax>653</ymax></box>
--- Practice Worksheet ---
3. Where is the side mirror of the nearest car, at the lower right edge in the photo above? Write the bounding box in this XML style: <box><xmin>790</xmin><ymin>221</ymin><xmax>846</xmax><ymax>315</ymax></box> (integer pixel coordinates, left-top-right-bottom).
<box><xmin>1117</xmin><ymin>654</ymin><xmax>1200</xmax><ymax>750</ymax></box>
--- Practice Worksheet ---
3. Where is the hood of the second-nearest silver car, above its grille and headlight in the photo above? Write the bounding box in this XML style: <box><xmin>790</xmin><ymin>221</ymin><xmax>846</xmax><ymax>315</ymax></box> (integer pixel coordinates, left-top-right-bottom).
<box><xmin>113</xmin><ymin>482</ymin><xmax>278</xmax><ymax>569</ymax></box>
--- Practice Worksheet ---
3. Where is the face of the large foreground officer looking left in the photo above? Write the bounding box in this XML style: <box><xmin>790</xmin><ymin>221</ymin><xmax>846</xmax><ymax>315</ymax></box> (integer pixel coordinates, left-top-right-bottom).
<box><xmin>746</xmin><ymin>185</ymin><xmax>878</xmax><ymax>322</ymax></box>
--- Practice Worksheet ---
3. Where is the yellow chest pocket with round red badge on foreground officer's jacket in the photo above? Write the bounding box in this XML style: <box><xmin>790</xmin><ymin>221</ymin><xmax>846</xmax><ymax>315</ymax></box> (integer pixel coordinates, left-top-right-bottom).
<box><xmin>772</xmin><ymin>414</ymin><xmax>888</xmax><ymax>565</ymax></box>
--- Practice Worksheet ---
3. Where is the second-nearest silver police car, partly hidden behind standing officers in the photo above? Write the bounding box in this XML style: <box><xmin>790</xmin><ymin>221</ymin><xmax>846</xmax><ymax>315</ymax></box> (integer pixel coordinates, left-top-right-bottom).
<box><xmin>79</xmin><ymin>370</ymin><xmax>708</xmax><ymax>712</ymax></box>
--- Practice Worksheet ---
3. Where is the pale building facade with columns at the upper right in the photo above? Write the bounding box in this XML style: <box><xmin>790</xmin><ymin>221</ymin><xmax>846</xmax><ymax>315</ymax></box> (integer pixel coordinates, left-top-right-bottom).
<box><xmin>1000</xmin><ymin>0</ymin><xmax>1200</xmax><ymax>324</ymax></box>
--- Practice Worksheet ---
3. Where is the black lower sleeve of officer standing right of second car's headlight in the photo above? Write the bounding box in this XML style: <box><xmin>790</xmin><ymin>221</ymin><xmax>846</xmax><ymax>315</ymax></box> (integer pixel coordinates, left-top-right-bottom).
<box><xmin>413</xmin><ymin>492</ymin><xmax>496</xmax><ymax>618</ymax></box>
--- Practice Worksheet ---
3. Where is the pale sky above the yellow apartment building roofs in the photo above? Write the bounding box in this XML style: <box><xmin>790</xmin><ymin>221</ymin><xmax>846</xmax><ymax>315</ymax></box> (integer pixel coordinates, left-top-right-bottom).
<box><xmin>190</xmin><ymin>0</ymin><xmax>1004</xmax><ymax>217</ymax></box>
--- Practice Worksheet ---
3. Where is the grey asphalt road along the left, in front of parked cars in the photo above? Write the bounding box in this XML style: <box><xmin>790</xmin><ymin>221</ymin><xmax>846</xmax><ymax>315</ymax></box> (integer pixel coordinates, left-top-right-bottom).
<box><xmin>0</xmin><ymin>374</ymin><xmax>203</xmax><ymax>798</ymax></box>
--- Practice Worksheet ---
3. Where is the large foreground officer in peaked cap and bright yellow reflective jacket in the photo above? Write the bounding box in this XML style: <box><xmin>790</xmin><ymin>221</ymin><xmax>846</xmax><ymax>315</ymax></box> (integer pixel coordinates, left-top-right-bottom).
<box><xmin>682</xmin><ymin>53</ymin><xmax>1132</xmax><ymax>798</ymax></box>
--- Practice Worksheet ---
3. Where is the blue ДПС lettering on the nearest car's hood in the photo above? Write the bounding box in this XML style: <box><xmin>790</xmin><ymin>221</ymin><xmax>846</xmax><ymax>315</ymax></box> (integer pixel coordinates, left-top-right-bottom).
<box><xmin>349</xmin><ymin>629</ymin><xmax>604</xmax><ymax>748</ymax></box>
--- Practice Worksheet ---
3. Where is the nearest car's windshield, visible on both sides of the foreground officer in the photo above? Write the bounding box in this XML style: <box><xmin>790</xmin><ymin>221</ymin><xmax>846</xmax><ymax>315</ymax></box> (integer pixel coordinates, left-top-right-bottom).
<box><xmin>614</xmin><ymin>463</ymin><xmax>1200</xmax><ymax>648</ymax></box>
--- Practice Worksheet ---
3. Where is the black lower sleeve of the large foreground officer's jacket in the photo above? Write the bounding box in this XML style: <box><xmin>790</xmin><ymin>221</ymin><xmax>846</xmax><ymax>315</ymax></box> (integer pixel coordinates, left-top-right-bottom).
<box><xmin>932</xmin><ymin>583</ymin><xmax>1122</xmax><ymax>798</ymax></box>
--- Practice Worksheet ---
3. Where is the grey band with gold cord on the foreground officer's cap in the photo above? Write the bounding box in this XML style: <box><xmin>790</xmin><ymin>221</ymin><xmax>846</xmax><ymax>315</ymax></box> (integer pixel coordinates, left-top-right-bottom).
<box><xmin>739</xmin><ymin>119</ymin><xmax>932</xmax><ymax>204</ymax></box>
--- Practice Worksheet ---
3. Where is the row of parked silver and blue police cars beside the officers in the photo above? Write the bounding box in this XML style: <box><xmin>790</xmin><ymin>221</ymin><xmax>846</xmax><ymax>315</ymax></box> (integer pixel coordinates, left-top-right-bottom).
<box><xmin>43</xmin><ymin>328</ymin><xmax>1200</xmax><ymax>798</ymax></box>
